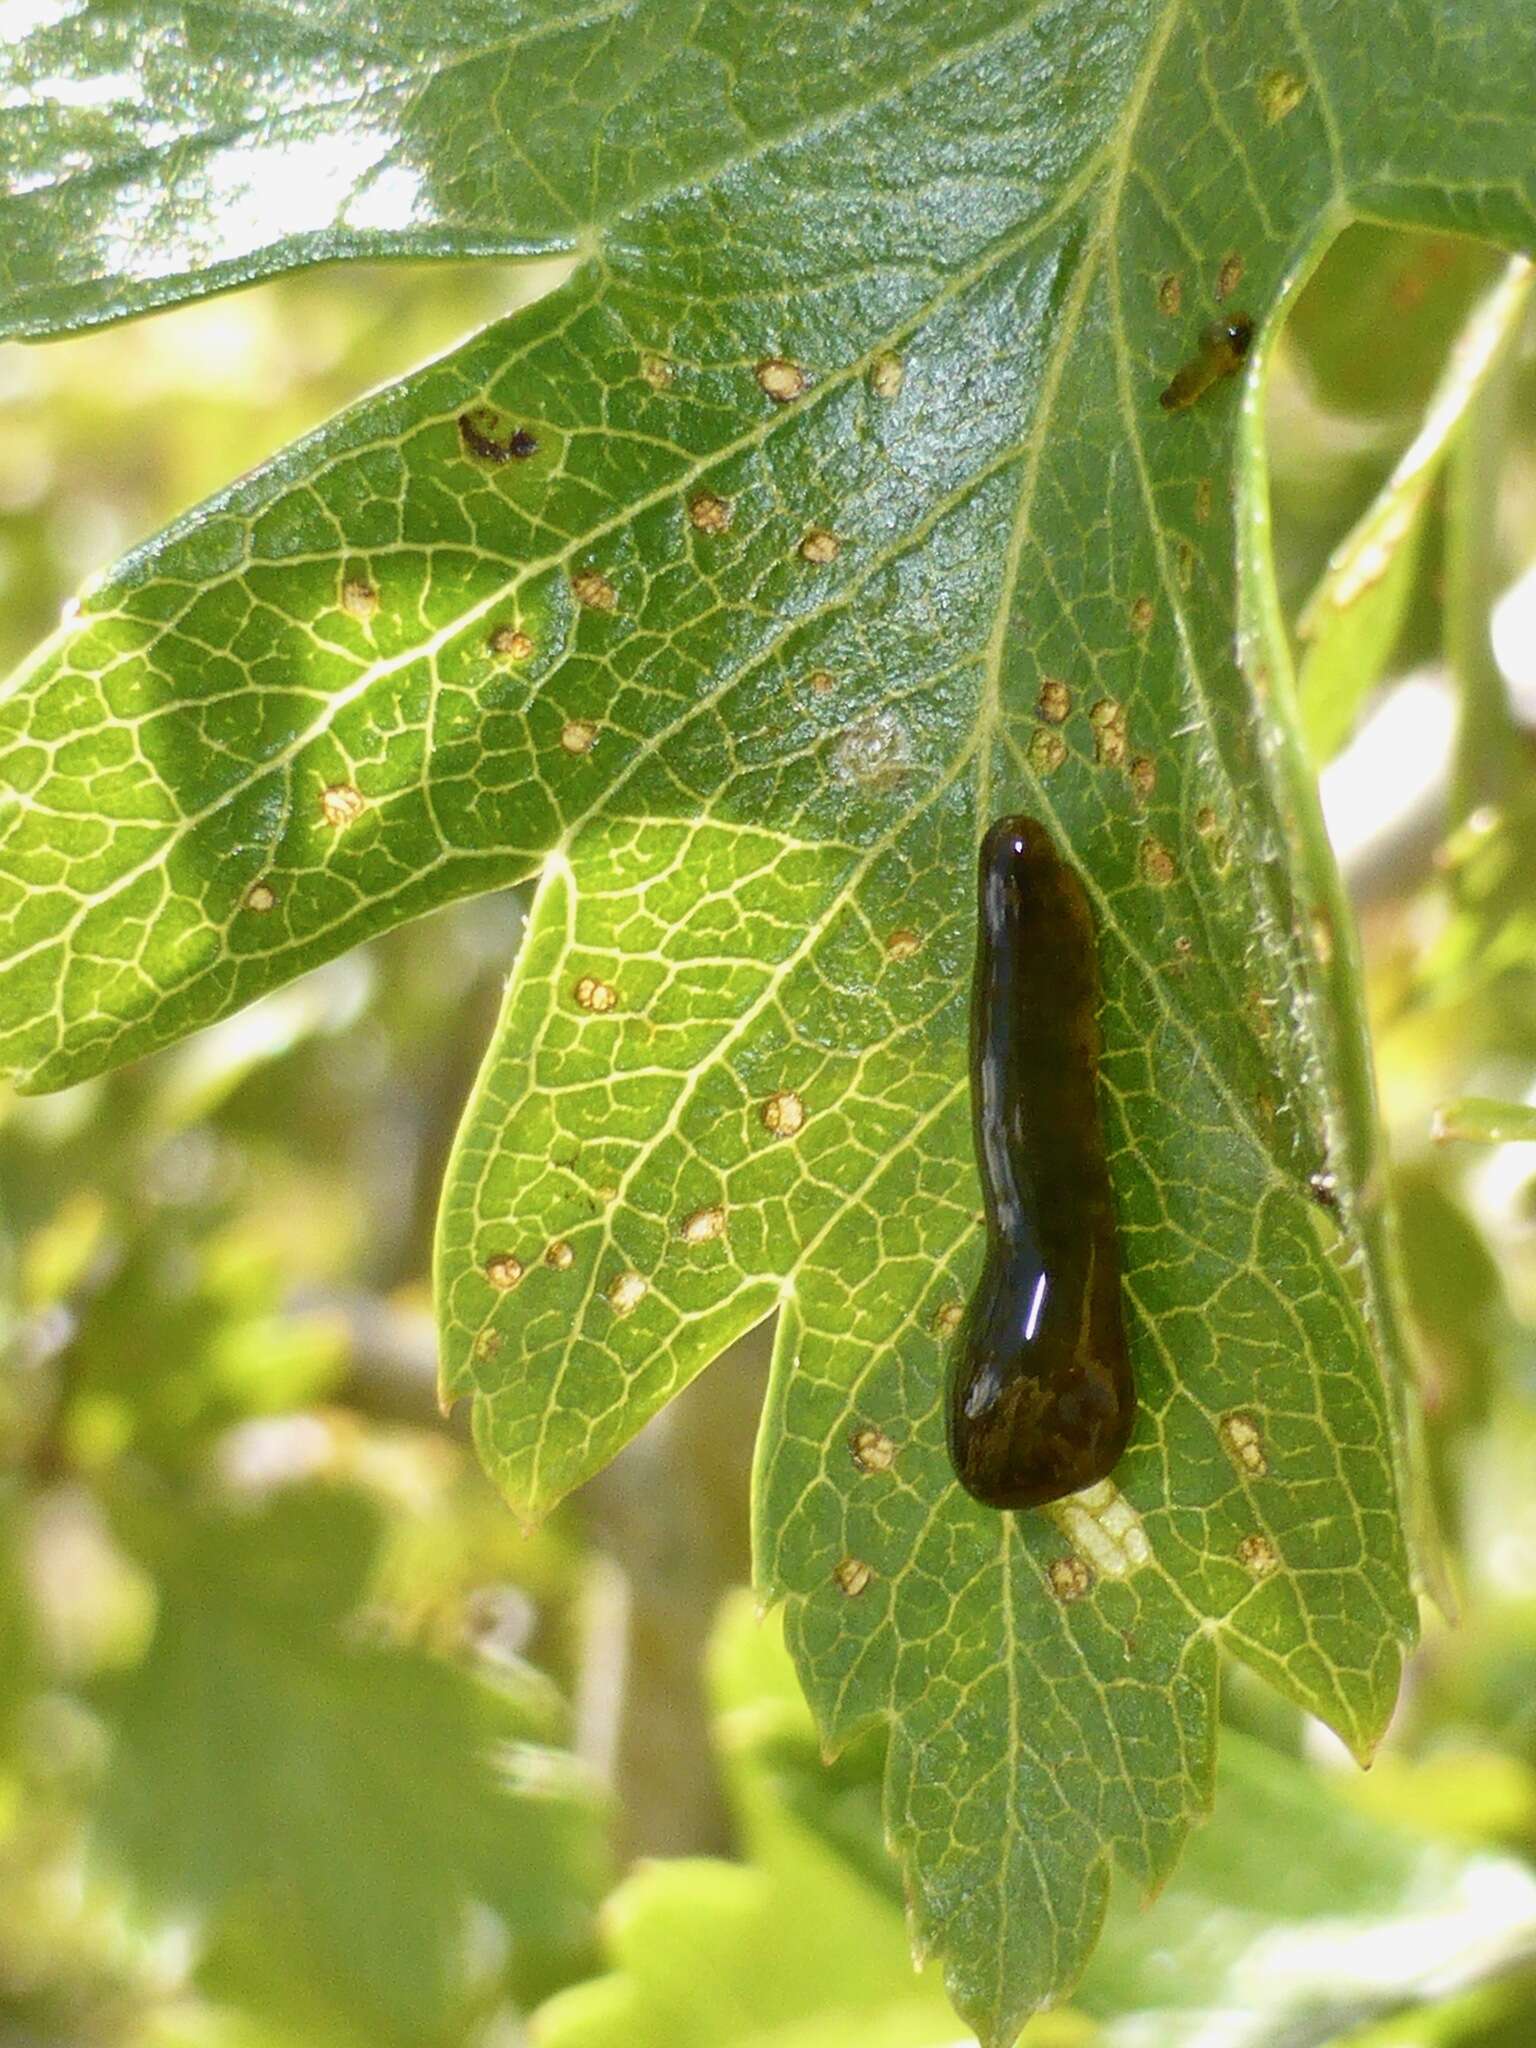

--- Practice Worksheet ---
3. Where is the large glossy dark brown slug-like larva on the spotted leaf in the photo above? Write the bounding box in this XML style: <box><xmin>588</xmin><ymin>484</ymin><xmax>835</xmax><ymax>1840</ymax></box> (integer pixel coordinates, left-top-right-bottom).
<box><xmin>946</xmin><ymin>817</ymin><xmax>1137</xmax><ymax>1507</ymax></box>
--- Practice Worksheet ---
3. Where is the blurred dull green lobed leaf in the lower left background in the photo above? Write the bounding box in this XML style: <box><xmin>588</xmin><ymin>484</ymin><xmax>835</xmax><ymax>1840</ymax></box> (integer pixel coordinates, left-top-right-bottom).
<box><xmin>94</xmin><ymin>1489</ymin><xmax>602</xmax><ymax>2044</ymax></box>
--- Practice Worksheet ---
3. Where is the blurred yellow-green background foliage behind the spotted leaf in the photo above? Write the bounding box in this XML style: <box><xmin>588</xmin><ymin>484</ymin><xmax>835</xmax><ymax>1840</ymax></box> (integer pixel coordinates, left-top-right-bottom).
<box><xmin>0</xmin><ymin>211</ymin><xmax>1536</xmax><ymax>2048</ymax></box>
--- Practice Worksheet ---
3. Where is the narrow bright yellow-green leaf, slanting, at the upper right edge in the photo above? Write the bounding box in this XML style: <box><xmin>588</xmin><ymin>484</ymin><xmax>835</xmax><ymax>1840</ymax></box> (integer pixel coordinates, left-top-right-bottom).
<box><xmin>1296</xmin><ymin>256</ymin><xmax>1532</xmax><ymax>762</ymax></box>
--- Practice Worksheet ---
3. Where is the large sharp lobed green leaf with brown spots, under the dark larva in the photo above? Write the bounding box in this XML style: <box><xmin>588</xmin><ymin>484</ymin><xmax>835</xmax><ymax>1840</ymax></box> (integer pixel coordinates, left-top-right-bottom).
<box><xmin>0</xmin><ymin>0</ymin><xmax>1536</xmax><ymax>2042</ymax></box>
